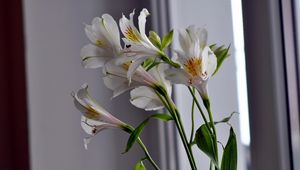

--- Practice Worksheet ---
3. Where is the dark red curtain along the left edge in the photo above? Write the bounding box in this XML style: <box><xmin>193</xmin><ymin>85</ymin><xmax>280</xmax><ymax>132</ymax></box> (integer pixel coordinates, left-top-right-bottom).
<box><xmin>0</xmin><ymin>0</ymin><xmax>29</xmax><ymax>170</ymax></box>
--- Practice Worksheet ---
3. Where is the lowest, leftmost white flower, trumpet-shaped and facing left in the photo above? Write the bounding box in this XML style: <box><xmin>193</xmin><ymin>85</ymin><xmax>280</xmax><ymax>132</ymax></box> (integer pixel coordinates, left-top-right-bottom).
<box><xmin>72</xmin><ymin>84</ymin><xmax>126</xmax><ymax>148</ymax></box>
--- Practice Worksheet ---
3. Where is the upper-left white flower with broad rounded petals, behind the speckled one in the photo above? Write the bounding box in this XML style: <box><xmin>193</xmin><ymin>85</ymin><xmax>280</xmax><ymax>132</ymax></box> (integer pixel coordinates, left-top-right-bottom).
<box><xmin>81</xmin><ymin>14</ymin><xmax>122</xmax><ymax>68</ymax></box>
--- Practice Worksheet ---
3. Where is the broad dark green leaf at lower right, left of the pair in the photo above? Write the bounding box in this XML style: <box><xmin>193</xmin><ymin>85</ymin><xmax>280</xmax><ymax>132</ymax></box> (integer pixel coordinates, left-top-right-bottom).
<box><xmin>195</xmin><ymin>124</ymin><xmax>219</xmax><ymax>167</ymax></box>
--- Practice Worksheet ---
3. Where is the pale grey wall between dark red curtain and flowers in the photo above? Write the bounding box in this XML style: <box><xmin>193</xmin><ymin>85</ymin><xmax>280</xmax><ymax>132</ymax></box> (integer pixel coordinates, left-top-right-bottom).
<box><xmin>24</xmin><ymin>0</ymin><xmax>157</xmax><ymax>170</ymax></box>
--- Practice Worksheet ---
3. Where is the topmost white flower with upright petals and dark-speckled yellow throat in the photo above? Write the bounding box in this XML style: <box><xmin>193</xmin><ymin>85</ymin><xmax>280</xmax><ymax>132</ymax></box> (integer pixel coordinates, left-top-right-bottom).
<box><xmin>119</xmin><ymin>8</ymin><xmax>160</xmax><ymax>78</ymax></box>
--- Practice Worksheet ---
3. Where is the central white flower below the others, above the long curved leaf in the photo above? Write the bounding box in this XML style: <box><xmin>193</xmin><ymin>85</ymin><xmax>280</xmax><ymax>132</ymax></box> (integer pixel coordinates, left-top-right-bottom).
<box><xmin>103</xmin><ymin>63</ymin><xmax>171</xmax><ymax>111</ymax></box>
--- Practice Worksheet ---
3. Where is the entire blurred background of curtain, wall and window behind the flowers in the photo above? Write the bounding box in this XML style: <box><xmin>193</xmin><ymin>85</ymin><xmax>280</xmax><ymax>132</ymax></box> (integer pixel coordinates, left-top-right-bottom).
<box><xmin>0</xmin><ymin>0</ymin><xmax>300</xmax><ymax>170</ymax></box>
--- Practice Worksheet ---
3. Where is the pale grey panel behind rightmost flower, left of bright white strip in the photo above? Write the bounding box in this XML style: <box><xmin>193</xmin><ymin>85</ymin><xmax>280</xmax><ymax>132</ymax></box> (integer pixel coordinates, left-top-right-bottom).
<box><xmin>170</xmin><ymin>0</ymin><xmax>246</xmax><ymax>170</ymax></box>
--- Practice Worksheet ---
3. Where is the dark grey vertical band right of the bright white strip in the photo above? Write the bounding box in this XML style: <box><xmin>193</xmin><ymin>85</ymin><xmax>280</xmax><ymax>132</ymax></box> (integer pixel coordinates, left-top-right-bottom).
<box><xmin>242</xmin><ymin>0</ymin><xmax>291</xmax><ymax>170</ymax></box>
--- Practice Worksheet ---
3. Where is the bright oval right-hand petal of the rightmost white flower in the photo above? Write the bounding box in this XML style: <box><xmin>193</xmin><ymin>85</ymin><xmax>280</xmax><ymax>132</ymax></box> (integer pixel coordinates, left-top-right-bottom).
<box><xmin>202</xmin><ymin>46</ymin><xmax>217</xmax><ymax>77</ymax></box>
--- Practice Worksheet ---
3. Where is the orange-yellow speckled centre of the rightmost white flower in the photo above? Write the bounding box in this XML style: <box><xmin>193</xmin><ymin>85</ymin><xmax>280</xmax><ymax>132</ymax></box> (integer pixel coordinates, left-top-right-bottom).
<box><xmin>184</xmin><ymin>57</ymin><xmax>202</xmax><ymax>77</ymax></box>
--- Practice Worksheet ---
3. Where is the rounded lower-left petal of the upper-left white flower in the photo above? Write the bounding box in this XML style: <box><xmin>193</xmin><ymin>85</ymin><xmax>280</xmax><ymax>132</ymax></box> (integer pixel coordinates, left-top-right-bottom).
<box><xmin>80</xmin><ymin>44</ymin><xmax>111</xmax><ymax>68</ymax></box>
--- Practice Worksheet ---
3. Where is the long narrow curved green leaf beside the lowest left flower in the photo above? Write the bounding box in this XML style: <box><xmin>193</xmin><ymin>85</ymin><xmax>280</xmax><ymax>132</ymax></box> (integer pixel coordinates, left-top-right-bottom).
<box><xmin>123</xmin><ymin>113</ymin><xmax>173</xmax><ymax>153</ymax></box>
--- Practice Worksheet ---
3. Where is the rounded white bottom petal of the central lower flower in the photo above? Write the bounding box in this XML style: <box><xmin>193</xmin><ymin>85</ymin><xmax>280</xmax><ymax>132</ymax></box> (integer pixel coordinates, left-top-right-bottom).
<box><xmin>130</xmin><ymin>86</ymin><xmax>163</xmax><ymax>111</ymax></box>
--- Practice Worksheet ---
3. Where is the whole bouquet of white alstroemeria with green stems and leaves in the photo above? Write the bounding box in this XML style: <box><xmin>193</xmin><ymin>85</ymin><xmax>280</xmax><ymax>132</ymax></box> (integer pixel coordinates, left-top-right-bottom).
<box><xmin>72</xmin><ymin>9</ymin><xmax>237</xmax><ymax>170</ymax></box>
